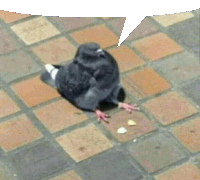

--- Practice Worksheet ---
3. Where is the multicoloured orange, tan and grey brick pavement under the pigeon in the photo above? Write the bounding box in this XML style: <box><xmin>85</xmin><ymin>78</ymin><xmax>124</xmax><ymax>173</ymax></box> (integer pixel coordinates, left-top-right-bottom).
<box><xmin>0</xmin><ymin>10</ymin><xmax>200</xmax><ymax>180</ymax></box>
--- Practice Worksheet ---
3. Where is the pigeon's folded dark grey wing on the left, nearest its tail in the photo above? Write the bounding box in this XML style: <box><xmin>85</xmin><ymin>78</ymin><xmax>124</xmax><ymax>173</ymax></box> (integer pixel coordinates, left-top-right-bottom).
<box><xmin>56</xmin><ymin>63</ymin><xmax>99</xmax><ymax>110</ymax></box>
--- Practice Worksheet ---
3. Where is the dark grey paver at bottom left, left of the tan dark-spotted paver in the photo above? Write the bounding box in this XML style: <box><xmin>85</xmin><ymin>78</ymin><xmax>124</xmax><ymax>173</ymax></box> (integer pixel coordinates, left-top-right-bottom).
<box><xmin>12</xmin><ymin>142</ymin><xmax>70</xmax><ymax>180</ymax></box>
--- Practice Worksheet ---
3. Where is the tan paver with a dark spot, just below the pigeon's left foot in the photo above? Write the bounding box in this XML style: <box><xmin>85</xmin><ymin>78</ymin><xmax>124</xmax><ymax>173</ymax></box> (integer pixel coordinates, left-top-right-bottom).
<box><xmin>57</xmin><ymin>124</ymin><xmax>113</xmax><ymax>162</ymax></box>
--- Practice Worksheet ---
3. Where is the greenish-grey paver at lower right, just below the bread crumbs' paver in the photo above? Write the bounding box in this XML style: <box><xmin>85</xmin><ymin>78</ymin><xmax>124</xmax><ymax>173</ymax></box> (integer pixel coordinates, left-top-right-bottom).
<box><xmin>129</xmin><ymin>134</ymin><xmax>185</xmax><ymax>172</ymax></box>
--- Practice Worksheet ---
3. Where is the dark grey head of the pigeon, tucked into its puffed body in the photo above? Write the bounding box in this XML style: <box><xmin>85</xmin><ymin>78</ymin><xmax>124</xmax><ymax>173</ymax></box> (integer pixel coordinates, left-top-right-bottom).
<box><xmin>76</xmin><ymin>42</ymin><xmax>105</xmax><ymax>59</ymax></box>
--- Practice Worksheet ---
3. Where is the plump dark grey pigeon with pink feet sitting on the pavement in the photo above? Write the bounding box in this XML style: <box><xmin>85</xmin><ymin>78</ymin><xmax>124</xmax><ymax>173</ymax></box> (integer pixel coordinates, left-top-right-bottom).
<box><xmin>41</xmin><ymin>42</ymin><xmax>139</xmax><ymax>123</ymax></box>
